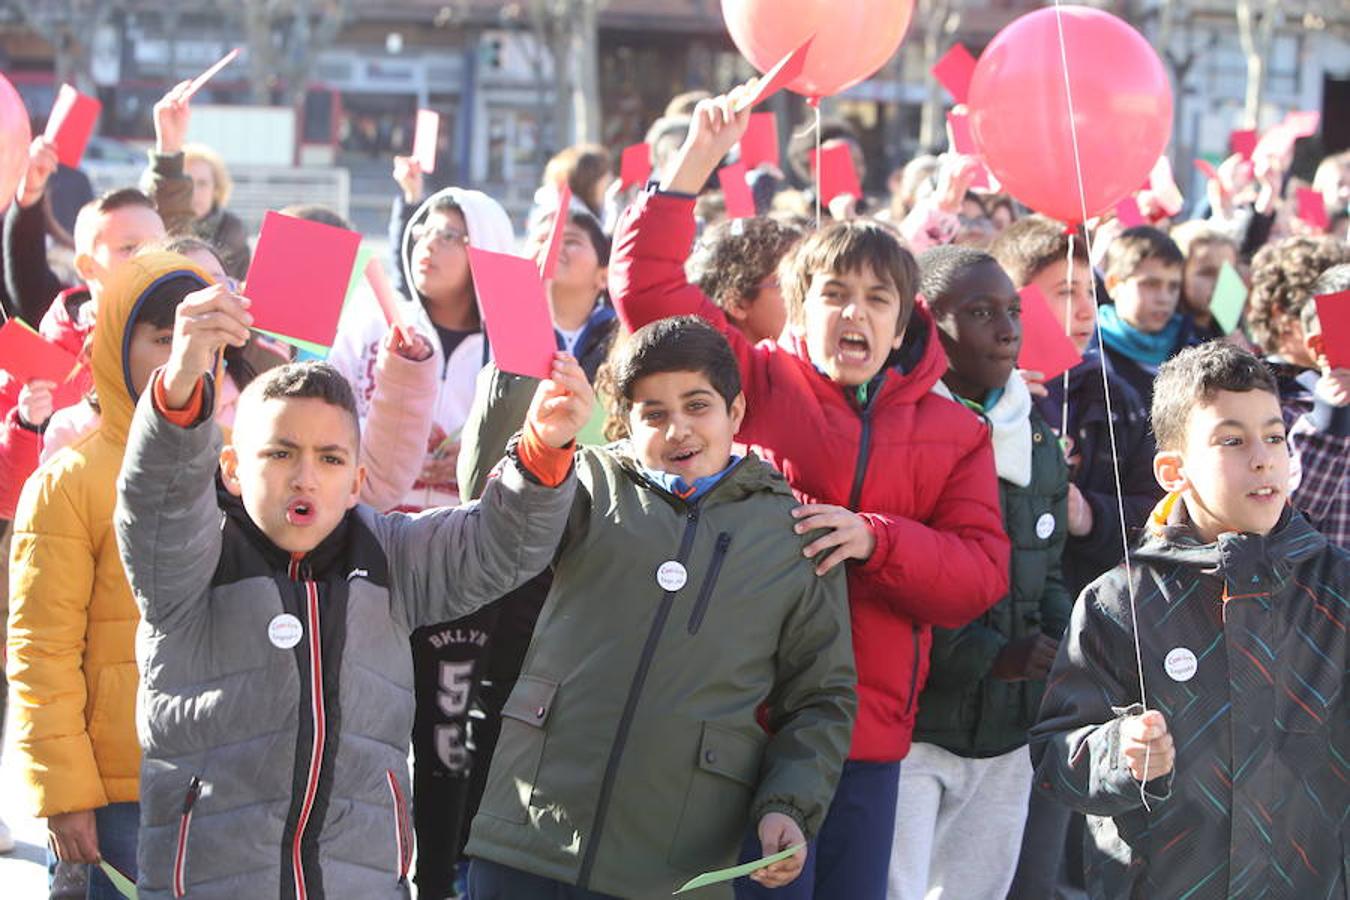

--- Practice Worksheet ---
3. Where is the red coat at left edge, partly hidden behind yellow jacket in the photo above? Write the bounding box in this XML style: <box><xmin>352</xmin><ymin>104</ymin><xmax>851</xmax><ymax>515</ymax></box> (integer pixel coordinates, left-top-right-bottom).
<box><xmin>0</xmin><ymin>286</ymin><xmax>93</xmax><ymax>519</ymax></box>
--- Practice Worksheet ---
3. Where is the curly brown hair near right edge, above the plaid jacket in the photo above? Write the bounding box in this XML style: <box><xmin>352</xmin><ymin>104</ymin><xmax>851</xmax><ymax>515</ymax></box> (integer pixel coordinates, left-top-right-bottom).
<box><xmin>1247</xmin><ymin>237</ymin><xmax>1350</xmax><ymax>354</ymax></box>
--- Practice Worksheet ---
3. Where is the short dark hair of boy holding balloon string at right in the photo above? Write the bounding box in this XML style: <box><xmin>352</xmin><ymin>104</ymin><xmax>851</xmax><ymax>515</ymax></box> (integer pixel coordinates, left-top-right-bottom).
<box><xmin>1152</xmin><ymin>340</ymin><xmax>1280</xmax><ymax>451</ymax></box>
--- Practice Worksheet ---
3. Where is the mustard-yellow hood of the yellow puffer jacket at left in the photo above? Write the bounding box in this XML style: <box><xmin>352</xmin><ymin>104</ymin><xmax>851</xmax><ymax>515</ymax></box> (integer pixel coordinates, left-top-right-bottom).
<box><xmin>93</xmin><ymin>252</ymin><xmax>211</xmax><ymax>443</ymax></box>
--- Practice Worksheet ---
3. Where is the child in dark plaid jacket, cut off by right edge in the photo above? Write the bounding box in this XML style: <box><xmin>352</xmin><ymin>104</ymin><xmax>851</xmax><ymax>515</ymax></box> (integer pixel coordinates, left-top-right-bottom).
<box><xmin>1289</xmin><ymin>263</ymin><xmax>1350</xmax><ymax>549</ymax></box>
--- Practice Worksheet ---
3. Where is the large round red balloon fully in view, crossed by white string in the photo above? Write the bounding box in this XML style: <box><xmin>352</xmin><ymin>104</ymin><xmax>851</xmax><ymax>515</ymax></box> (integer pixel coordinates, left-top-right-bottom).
<box><xmin>967</xmin><ymin>7</ymin><xmax>1172</xmax><ymax>224</ymax></box>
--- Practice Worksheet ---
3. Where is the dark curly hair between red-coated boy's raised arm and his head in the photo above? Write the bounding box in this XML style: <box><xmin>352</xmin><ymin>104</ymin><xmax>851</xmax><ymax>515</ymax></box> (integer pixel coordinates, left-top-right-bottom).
<box><xmin>684</xmin><ymin>217</ymin><xmax>803</xmax><ymax>309</ymax></box>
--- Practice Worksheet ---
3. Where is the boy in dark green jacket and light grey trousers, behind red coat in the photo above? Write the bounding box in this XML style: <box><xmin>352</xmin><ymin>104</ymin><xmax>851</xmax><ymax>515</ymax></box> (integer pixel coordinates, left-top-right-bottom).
<box><xmin>887</xmin><ymin>247</ymin><xmax>1072</xmax><ymax>900</ymax></box>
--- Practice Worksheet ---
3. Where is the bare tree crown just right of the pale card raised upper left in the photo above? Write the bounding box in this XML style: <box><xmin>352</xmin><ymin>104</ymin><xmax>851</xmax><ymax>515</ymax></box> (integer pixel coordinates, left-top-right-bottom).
<box><xmin>236</xmin><ymin>0</ymin><xmax>352</xmax><ymax>107</ymax></box>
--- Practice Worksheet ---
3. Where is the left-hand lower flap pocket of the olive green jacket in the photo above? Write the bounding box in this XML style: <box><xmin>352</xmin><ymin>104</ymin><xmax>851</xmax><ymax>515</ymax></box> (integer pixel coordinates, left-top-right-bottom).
<box><xmin>481</xmin><ymin>675</ymin><xmax>558</xmax><ymax>824</ymax></box>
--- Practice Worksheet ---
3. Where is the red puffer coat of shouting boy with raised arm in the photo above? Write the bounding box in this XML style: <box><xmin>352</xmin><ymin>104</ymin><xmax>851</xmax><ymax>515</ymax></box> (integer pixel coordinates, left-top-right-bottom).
<box><xmin>609</xmin><ymin>194</ymin><xmax>1010</xmax><ymax>761</ymax></box>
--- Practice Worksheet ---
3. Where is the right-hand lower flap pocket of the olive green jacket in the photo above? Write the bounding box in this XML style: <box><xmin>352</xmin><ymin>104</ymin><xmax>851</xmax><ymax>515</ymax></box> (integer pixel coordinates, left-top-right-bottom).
<box><xmin>670</xmin><ymin>722</ymin><xmax>764</xmax><ymax>874</ymax></box>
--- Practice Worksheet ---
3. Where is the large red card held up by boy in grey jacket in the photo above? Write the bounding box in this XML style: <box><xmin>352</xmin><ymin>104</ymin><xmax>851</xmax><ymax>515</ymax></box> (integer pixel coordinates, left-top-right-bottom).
<box><xmin>246</xmin><ymin>212</ymin><xmax>360</xmax><ymax>347</ymax></box>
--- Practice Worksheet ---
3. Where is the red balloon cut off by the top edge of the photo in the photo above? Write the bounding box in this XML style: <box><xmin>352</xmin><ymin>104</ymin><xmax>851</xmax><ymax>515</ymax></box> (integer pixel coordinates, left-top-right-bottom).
<box><xmin>722</xmin><ymin>0</ymin><xmax>914</xmax><ymax>99</ymax></box>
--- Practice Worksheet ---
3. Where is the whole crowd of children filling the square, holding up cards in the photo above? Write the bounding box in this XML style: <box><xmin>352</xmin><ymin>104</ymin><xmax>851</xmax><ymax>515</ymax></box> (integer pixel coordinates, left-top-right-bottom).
<box><xmin>0</xmin><ymin>65</ymin><xmax>1350</xmax><ymax>900</ymax></box>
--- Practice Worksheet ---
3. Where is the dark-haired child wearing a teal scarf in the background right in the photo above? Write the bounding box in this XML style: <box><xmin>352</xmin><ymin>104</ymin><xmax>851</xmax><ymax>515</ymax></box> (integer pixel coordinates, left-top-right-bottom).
<box><xmin>1098</xmin><ymin>225</ymin><xmax>1197</xmax><ymax>406</ymax></box>
